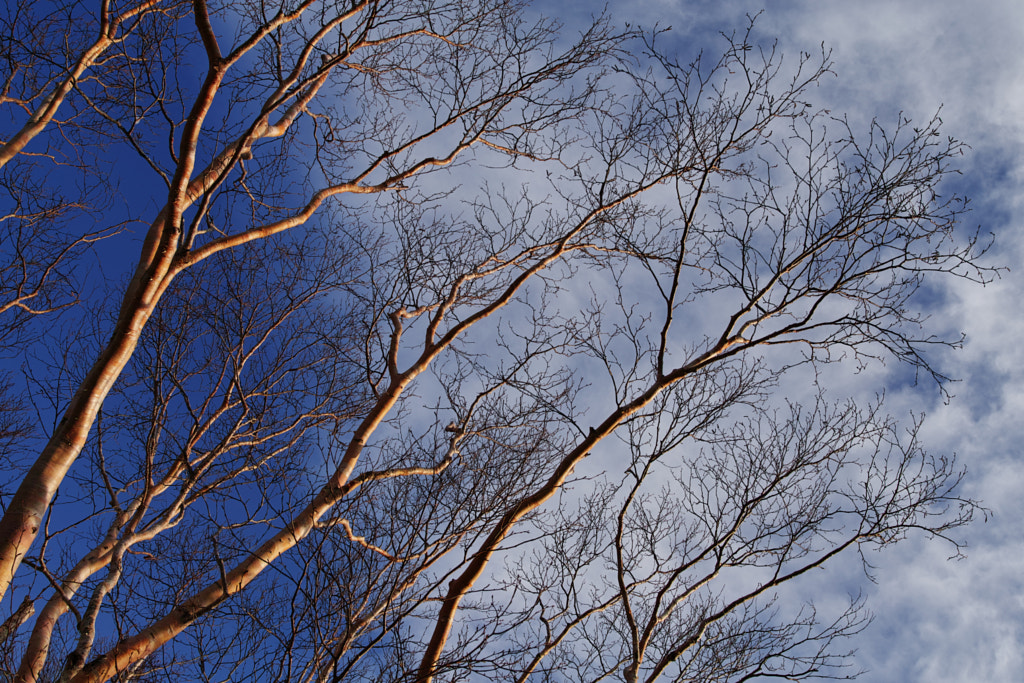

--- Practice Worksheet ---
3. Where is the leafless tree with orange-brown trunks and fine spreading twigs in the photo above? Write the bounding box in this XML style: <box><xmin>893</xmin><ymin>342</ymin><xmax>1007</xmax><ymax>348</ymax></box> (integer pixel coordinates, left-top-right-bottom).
<box><xmin>0</xmin><ymin>5</ymin><xmax>989</xmax><ymax>682</ymax></box>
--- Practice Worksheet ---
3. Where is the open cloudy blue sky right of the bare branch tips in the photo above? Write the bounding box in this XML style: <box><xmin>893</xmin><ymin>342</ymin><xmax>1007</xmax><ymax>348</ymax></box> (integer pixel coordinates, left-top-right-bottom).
<box><xmin>589</xmin><ymin>0</ymin><xmax>1024</xmax><ymax>683</ymax></box>
